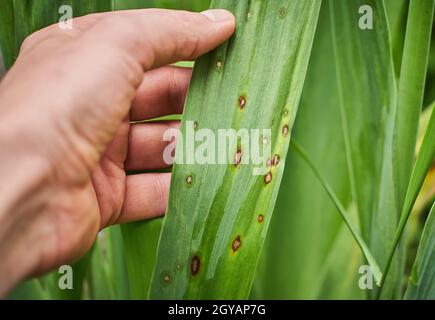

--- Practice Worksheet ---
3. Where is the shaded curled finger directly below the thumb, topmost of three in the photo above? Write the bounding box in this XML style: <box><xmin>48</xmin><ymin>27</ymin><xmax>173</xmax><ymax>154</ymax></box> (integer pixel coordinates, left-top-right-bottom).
<box><xmin>130</xmin><ymin>67</ymin><xmax>192</xmax><ymax>121</ymax></box>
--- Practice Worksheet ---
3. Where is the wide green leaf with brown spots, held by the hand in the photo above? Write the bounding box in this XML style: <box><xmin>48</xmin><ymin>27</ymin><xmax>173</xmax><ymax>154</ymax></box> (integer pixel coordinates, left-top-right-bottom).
<box><xmin>150</xmin><ymin>0</ymin><xmax>320</xmax><ymax>299</ymax></box>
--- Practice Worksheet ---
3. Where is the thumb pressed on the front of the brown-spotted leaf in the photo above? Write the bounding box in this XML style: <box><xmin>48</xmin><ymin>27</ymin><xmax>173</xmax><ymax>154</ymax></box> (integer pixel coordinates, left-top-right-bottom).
<box><xmin>81</xmin><ymin>9</ymin><xmax>235</xmax><ymax>70</ymax></box>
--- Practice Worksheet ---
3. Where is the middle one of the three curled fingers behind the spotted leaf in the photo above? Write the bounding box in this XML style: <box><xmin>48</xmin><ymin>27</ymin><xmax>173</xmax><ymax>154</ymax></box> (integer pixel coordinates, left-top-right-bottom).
<box><xmin>125</xmin><ymin>121</ymin><xmax>180</xmax><ymax>171</ymax></box>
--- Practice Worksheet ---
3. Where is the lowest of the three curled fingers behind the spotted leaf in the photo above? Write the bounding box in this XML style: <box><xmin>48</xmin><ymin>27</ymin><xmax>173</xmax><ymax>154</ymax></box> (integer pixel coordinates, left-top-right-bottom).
<box><xmin>116</xmin><ymin>173</ymin><xmax>171</xmax><ymax>223</ymax></box>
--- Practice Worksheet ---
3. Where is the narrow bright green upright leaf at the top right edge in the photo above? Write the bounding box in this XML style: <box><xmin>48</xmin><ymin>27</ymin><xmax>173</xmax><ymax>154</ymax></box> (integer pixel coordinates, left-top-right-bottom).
<box><xmin>394</xmin><ymin>0</ymin><xmax>435</xmax><ymax>208</ymax></box>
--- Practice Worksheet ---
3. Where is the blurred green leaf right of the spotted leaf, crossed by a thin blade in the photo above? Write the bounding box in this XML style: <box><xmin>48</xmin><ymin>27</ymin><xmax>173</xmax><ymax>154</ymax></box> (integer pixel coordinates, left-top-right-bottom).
<box><xmin>251</xmin><ymin>1</ymin><xmax>364</xmax><ymax>299</ymax></box>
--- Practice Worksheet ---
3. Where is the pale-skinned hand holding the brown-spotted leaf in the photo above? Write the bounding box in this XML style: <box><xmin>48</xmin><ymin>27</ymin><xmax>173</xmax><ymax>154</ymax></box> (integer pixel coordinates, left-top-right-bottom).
<box><xmin>0</xmin><ymin>9</ymin><xmax>235</xmax><ymax>297</ymax></box>
